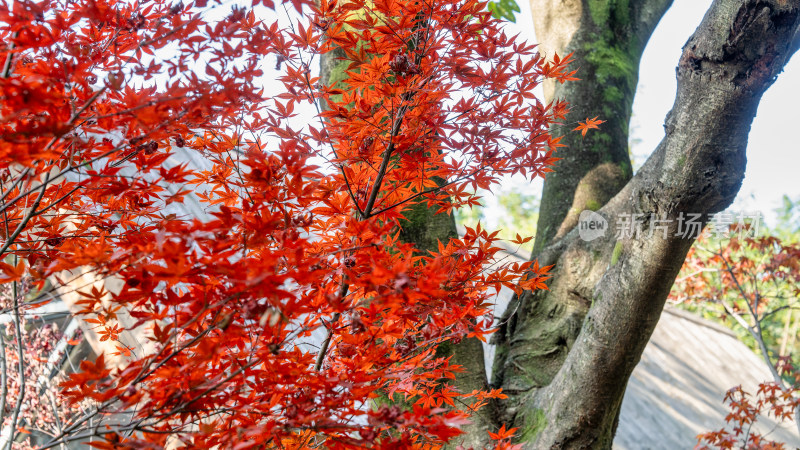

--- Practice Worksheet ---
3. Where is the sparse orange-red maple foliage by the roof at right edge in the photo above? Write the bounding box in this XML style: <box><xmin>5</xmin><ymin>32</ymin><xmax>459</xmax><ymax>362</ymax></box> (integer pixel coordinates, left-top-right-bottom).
<box><xmin>670</xmin><ymin>230</ymin><xmax>800</xmax><ymax>449</ymax></box>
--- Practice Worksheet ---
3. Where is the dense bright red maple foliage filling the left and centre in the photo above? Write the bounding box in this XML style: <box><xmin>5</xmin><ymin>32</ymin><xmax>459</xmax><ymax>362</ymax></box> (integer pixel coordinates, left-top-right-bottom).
<box><xmin>0</xmin><ymin>0</ymin><xmax>574</xmax><ymax>449</ymax></box>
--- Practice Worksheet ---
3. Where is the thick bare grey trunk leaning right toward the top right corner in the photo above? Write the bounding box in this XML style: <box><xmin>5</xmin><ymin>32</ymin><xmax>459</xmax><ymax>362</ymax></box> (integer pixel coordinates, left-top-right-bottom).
<box><xmin>506</xmin><ymin>0</ymin><xmax>800</xmax><ymax>448</ymax></box>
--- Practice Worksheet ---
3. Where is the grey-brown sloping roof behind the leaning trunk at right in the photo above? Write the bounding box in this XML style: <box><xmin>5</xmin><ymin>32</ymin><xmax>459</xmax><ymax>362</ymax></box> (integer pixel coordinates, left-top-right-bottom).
<box><xmin>484</xmin><ymin>244</ymin><xmax>800</xmax><ymax>450</ymax></box>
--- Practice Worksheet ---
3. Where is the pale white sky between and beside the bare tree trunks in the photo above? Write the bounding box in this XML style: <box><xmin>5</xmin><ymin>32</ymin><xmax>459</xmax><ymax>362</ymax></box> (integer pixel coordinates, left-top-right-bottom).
<box><xmin>485</xmin><ymin>0</ymin><xmax>800</xmax><ymax>225</ymax></box>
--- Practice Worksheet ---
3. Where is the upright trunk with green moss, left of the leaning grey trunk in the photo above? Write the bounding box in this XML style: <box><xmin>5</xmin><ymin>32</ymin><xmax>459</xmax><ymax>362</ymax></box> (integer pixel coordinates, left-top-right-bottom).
<box><xmin>531</xmin><ymin>0</ymin><xmax>672</xmax><ymax>254</ymax></box>
